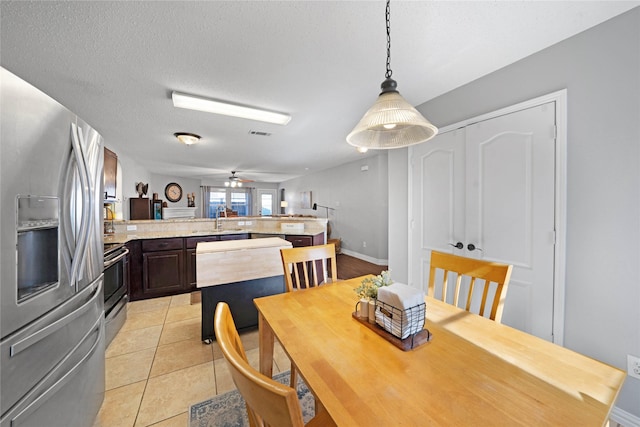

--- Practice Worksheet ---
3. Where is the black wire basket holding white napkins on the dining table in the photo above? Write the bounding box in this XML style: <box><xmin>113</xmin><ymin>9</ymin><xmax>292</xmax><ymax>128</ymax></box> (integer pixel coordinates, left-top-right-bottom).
<box><xmin>376</xmin><ymin>300</ymin><xmax>426</xmax><ymax>340</ymax></box>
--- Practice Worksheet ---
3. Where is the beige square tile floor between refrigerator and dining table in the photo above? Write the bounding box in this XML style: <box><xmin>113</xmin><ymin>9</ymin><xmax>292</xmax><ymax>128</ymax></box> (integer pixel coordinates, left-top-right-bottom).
<box><xmin>94</xmin><ymin>294</ymin><xmax>290</xmax><ymax>427</ymax></box>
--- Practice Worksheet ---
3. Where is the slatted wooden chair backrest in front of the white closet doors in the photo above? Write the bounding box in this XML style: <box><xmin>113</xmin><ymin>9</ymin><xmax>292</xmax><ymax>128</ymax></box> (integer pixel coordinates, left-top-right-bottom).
<box><xmin>428</xmin><ymin>251</ymin><xmax>513</xmax><ymax>323</ymax></box>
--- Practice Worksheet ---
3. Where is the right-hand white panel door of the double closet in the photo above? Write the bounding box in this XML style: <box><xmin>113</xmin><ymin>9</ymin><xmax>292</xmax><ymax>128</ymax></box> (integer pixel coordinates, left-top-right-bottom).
<box><xmin>466</xmin><ymin>103</ymin><xmax>555</xmax><ymax>340</ymax></box>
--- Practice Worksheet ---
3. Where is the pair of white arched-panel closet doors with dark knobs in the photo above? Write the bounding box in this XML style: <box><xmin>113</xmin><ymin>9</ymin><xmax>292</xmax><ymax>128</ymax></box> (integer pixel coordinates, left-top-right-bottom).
<box><xmin>410</xmin><ymin>102</ymin><xmax>555</xmax><ymax>340</ymax></box>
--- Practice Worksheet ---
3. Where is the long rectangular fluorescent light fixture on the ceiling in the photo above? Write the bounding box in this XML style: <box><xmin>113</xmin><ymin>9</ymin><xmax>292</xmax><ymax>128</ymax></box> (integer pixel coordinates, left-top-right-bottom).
<box><xmin>171</xmin><ymin>92</ymin><xmax>291</xmax><ymax>125</ymax></box>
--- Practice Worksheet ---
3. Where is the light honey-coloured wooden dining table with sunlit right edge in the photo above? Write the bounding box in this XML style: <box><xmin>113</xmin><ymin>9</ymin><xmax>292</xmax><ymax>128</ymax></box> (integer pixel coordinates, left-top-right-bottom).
<box><xmin>254</xmin><ymin>277</ymin><xmax>625</xmax><ymax>426</ymax></box>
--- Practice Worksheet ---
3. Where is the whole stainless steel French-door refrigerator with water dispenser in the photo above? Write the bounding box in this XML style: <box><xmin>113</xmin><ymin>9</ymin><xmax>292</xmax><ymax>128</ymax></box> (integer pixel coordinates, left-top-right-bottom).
<box><xmin>0</xmin><ymin>67</ymin><xmax>105</xmax><ymax>427</ymax></box>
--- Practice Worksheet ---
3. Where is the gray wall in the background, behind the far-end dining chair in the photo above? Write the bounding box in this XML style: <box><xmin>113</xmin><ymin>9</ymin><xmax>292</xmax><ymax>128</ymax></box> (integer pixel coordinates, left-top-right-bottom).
<box><xmin>278</xmin><ymin>150</ymin><xmax>390</xmax><ymax>265</ymax></box>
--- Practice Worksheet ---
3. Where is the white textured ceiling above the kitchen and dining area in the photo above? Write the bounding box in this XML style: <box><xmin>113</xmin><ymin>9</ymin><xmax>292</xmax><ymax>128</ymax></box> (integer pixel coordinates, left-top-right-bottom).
<box><xmin>0</xmin><ymin>0</ymin><xmax>640</xmax><ymax>182</ymax></box>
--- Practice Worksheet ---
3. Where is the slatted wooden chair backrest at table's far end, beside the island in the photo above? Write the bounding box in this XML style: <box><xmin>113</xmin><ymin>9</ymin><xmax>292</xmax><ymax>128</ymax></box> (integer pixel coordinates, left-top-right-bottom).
<box><xmin>280</xmin><ymin>243</ymin><xmax>338</xmax><ymax>292</ymax></box>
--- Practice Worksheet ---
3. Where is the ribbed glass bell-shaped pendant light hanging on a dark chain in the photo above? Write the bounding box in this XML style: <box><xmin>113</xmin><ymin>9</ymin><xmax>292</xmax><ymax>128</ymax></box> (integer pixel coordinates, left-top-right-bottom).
<box><xmin>347</xmin><ymin>0</ymin><xmax>438</xmax><ymax>150</ymax></box>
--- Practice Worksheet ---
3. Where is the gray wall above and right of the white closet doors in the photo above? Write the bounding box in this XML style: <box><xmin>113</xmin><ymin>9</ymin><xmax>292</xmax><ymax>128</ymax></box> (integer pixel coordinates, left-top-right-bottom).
<box><xmin>389</xmin><ymin>8</ymin><xmax>640</xmax><ymax>418</ymax></box>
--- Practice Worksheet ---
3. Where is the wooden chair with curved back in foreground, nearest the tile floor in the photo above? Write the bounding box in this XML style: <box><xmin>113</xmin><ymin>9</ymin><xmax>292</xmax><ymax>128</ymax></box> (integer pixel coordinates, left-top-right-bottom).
<box><xmin>213</xmin><ymin>302</ymin><xmax>336</xmax><ymax>427</ymax></box>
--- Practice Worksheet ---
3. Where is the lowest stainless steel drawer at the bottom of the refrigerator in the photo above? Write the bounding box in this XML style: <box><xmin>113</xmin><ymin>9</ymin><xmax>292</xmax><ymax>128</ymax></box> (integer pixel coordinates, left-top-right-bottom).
<box><xmin>0</xmin><ymin>317</ymin><xmax>105</xmax><ymax>427</ymax></box>
